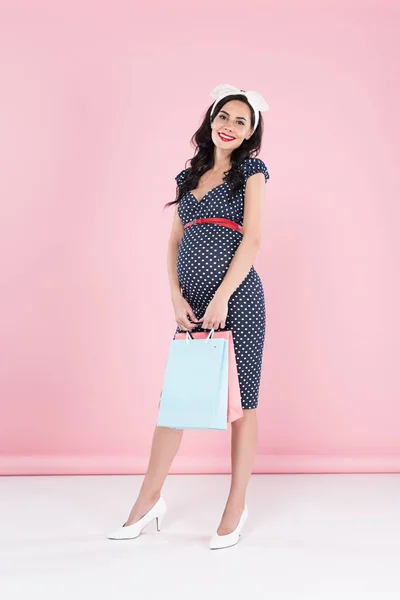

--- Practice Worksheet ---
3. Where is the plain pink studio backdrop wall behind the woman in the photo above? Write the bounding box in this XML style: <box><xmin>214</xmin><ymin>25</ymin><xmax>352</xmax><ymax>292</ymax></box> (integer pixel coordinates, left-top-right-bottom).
<box><xmin>0</xmin><ymin>0</ymin><xmax>400</xmax><ymax>474</ymax></box>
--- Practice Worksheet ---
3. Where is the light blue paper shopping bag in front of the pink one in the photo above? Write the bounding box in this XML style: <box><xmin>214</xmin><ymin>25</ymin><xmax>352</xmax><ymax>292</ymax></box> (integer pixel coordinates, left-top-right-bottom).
<box><xmin>157</xmin><ymin>329</ymin><xmax>228</xmax><ymax>429</ymax></box>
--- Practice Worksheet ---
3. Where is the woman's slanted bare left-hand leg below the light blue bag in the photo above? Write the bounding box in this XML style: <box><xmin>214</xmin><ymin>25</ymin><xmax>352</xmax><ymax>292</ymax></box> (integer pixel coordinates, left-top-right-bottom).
<box><xmin>124</xmin><ymin>425</ymin><xmax>183</xmax><ymax>525</ymax></box>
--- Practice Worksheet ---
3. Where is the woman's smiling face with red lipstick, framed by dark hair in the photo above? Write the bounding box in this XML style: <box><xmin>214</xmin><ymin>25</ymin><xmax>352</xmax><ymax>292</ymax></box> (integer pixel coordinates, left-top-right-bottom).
<box><xmin>211</xmin><ymin>100</ymin><xmax>252</xmax><ymax>152</ymax></box>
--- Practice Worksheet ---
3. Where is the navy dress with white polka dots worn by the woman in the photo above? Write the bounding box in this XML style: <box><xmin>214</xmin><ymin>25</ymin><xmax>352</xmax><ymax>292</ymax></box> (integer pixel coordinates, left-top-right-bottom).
<box><xmin>175</xmin><ymin>158</ymin><xmax>269</xmax><ymax>409</ymax></box>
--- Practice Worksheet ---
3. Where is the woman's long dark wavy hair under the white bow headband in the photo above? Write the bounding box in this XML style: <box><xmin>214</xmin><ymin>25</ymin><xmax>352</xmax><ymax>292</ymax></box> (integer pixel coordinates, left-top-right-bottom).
<box><xmin>164</xmin><ymin>94</ymin><xmax>264</xmax><ymax>208</ymax></box>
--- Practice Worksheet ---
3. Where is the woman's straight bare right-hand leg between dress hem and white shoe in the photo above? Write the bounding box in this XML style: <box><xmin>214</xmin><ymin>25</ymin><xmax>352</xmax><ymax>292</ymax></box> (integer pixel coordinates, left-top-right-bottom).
<box><xmin>217</xmin><ymin>408</ymin><xmax>258</xmax><ymax>535</ymax></box>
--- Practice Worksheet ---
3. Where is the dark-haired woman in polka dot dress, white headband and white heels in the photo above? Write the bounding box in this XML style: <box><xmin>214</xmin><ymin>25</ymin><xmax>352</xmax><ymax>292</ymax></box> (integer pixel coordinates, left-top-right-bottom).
<box><xmin>108</xmin><ymin>84</ymin><xmax>269</xmax><ymax>548</ymax></box>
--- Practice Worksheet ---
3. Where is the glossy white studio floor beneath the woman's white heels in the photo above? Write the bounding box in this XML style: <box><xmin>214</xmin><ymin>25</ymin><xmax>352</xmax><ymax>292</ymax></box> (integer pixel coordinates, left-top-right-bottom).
<box><xmin>0</xmin><ymin>474</ymin><xmax>400</xmax><ymax>600</ymax></box>
